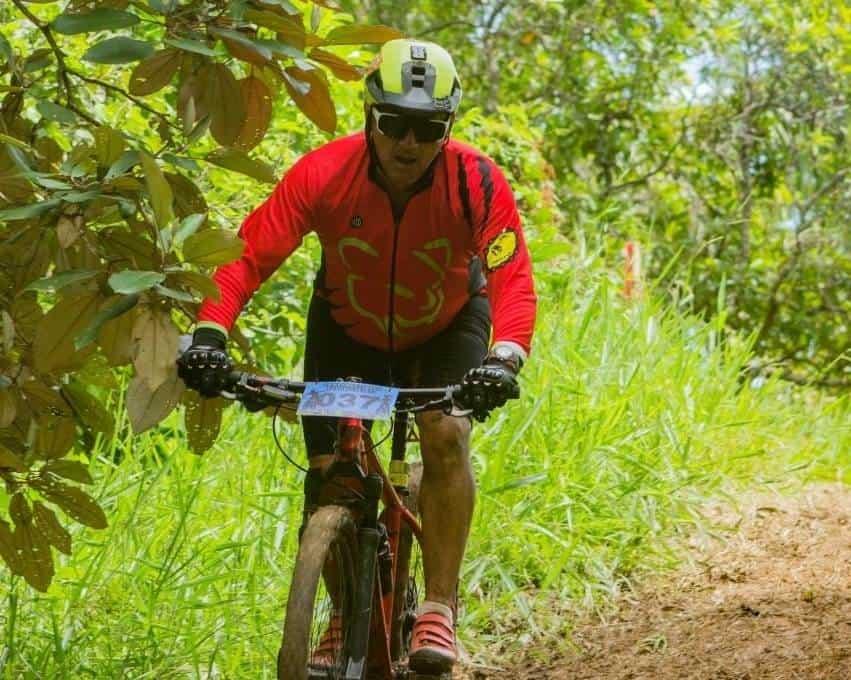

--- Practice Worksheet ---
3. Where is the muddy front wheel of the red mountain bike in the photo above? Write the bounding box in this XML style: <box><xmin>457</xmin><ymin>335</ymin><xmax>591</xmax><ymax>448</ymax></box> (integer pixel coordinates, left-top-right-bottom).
<box><xmin>278</xmin><ymin>505</ymin><xmax>357</xmax><ymax>680</ymax></box>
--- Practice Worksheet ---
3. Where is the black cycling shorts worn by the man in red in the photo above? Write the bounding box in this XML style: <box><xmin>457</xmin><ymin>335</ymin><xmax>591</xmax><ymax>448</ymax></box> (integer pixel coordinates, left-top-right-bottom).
<box><xmin>302</xmin><ymin>295</ymin><xmax>491</xmax><ymax>456</ymax></box>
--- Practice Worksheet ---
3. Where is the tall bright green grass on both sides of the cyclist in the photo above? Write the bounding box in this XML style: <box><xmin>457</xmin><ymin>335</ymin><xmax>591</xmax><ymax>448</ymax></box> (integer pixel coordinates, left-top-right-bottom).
<box><xmin>0</xmin><ymin>266</ymin><xmax>851</xmax><ymax>679</ymax></box>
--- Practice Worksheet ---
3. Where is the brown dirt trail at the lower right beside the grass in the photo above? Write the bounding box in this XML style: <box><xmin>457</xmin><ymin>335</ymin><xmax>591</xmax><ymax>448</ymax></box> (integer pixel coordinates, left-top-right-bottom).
<box><xmin>459</xmin><ymin>485</ymin><xmax>851</xmax><ymax>680</ymax></box>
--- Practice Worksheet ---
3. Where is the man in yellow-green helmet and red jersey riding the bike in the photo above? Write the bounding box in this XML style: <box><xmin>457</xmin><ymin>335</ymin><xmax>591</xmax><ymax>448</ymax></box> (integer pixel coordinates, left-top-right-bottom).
<box><xmin>180</xmin><ymin>40</ymin><xmax>536</xmax><ymax>673</ymax></box>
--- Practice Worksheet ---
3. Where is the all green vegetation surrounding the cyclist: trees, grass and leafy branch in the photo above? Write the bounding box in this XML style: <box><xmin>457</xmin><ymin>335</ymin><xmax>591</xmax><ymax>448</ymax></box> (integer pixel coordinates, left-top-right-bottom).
<box><xmin>0</xmin><ymin>0</ymin><xmax>851</xmax><ymax>677</ymax></box>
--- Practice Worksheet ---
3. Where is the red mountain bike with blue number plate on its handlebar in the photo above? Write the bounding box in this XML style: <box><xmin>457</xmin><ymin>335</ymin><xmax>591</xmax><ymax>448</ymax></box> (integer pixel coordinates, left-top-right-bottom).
<box><xmin>222</xmin><ymin>372</ymin><xmax>468</xmax><ymax>680</ymax></box>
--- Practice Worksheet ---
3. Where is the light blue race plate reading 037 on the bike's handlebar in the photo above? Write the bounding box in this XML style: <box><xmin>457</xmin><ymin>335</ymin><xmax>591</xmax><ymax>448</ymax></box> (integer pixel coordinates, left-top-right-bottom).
<box><xmin>297</xmin><ymin>381</ymin><xmax>399</xmax><ymax>420</ymax></box>
